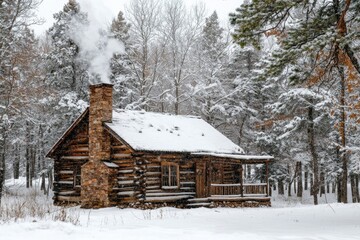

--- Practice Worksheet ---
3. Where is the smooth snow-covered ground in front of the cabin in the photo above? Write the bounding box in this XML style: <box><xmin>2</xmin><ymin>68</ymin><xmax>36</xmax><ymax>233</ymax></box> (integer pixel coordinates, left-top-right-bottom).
<box><xmin>0</xmin><ymin>179</ymin><xmax>360</xmax><ymax>240</ymax></box>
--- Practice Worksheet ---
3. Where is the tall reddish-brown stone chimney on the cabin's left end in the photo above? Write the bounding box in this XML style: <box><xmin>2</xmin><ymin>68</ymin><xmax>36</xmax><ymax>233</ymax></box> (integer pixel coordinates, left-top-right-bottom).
<box><xmin>81</xmin><ymin>83</ymin><xmax>117</xmax><ymax>208</ymax></box>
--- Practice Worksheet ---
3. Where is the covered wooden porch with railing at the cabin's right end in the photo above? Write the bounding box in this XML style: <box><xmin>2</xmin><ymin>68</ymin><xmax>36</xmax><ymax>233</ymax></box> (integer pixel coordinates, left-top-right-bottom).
<box><xmin>189</xmin><ymin>156</ymin><xmax>271</xmax><ymax>207</ymax></box>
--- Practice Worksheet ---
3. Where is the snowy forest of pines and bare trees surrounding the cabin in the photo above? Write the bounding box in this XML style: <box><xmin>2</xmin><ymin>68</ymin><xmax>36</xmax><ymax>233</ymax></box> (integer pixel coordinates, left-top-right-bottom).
<box><xmin>0</xmin><ymin>0</ymin><xmax>360</xmax><ymax>204</ymax></box>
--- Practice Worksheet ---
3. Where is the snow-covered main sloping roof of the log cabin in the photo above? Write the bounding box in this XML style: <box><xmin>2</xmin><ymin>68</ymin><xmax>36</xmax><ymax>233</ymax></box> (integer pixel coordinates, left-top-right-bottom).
<box><xmin>106</xmin><ymin>110</ymin><xmax>244</xmax><ymax>154</ymax></box>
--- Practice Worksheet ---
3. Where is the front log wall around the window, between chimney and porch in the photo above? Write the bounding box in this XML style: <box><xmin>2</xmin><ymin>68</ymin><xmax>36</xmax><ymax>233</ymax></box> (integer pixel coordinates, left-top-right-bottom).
<box><xmin>111</xmin><ymin>137</ymin><xmax>196</xmax><ymax>206</ymax></box>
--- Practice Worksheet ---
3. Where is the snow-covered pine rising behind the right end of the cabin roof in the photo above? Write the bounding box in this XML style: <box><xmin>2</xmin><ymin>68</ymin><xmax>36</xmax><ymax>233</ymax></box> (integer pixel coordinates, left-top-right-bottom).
<box><xmin>226</xmin><ymin>45</ymin><xmax>266</xmax><ymax>153</ymax></box>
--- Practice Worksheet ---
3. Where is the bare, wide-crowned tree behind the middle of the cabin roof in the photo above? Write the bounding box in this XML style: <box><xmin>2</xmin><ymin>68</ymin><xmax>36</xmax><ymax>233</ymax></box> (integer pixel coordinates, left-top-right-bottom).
<box><xmin>161</xmin><ymin>0</ymin><xmax>205</xmax><ymax>114</ymax></box>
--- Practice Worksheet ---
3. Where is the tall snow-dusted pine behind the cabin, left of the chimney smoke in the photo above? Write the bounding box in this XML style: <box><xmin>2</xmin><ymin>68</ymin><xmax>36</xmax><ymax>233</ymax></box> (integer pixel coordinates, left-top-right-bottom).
<box><xmin>45</xmin><ymin>0</ymin><xmax>89</xmax><ymax>152</ymax></box>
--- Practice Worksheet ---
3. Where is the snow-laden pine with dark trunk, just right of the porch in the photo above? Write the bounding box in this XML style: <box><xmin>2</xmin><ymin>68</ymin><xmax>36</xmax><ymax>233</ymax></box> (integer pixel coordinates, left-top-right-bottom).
<box><xmin>268</xmin><ymin>87</ymin><xmax>336</xmax><ymax>202</ymax></box>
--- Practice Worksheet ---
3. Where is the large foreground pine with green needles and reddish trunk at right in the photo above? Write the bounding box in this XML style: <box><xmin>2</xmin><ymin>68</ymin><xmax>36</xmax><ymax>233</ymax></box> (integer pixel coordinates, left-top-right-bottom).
<box><xmin>230</xmin><ymin>0</ymin><xmax>360</xmax><ymax>202</ymax></box>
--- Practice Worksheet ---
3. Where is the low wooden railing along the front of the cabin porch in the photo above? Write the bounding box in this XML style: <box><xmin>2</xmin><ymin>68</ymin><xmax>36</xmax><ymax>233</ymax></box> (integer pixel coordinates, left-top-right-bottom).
<box><xmin>210</xmin><ymin>183</ymin><xmax>267</xmax><ymax>196</ymax></box>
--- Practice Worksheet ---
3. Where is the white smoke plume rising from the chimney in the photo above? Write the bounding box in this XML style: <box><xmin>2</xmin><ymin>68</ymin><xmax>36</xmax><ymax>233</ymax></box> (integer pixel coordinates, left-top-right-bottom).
<box><xmin>69</xmin><ymin>0</ymin><xmax>125</xmax><ymax>84</ymax></box>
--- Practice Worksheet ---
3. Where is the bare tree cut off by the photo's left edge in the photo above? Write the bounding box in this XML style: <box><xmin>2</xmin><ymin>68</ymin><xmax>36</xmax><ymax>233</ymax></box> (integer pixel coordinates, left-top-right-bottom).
<box><xmin>0</xmin><ymin>0</ymin><xmax>41</xmax><ymax>201</ymax></box>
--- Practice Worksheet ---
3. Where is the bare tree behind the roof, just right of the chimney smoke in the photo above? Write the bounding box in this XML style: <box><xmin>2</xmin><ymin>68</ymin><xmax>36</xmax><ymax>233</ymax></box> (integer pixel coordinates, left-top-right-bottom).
<box><xmin>126</xmin><ymin>0</ymin><xmax>162</xmax><ymax>110</ymax></box>
